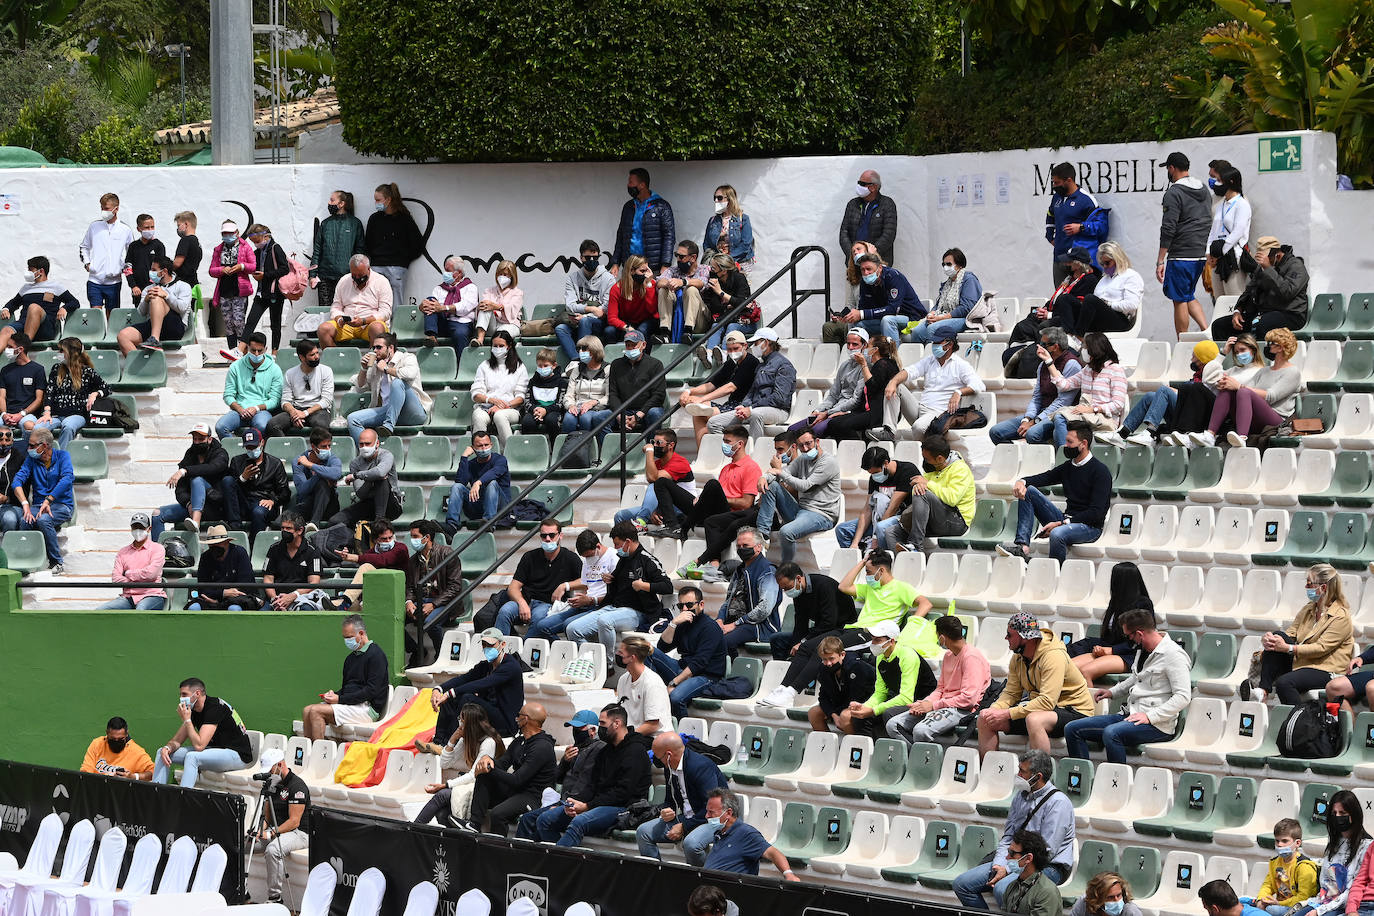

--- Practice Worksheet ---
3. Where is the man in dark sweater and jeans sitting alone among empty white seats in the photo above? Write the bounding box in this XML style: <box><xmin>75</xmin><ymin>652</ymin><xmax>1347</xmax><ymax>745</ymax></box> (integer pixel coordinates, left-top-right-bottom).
<box><xmin>998</xmin><ymin>420</ymin><xmax>1112</xmax><ymax>563</ymax></box>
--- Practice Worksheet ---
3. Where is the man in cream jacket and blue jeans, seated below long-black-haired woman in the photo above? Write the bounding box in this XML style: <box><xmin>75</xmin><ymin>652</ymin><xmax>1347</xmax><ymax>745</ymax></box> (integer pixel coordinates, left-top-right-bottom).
<box><xmin>1063</xmin><ymin>608</ymin><xmax>1193</xmax><ymax>764</ymax></box>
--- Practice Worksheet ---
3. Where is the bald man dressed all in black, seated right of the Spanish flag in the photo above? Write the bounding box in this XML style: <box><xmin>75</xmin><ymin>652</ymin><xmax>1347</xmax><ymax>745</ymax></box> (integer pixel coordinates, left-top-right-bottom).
<box><xmin>469</xmin><ymin>703</ymin><xmax>558</xmax><ymax>836</ymax></box>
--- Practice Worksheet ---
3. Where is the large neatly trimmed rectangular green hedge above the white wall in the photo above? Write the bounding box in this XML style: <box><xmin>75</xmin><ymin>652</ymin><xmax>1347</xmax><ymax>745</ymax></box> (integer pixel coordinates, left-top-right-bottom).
<box><xmin>337</xmin><ymin>0</ymin><xmax>934</xmax><ymax>161</ymax></box>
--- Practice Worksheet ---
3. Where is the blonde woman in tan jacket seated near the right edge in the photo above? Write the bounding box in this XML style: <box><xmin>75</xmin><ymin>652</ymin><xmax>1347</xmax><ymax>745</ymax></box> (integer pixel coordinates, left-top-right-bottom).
<box><xmin>1241</xmin><ymin>563</ymin><xmax>1355</xmax><ymax>706</ymax></box>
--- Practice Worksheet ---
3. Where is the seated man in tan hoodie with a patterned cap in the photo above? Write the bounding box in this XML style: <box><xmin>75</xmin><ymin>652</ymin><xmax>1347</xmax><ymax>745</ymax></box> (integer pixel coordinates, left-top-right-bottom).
<box><xmin>978</xmin><ymin>611</ymin><xmax>1094</xmax><ymax>758</ymax></box>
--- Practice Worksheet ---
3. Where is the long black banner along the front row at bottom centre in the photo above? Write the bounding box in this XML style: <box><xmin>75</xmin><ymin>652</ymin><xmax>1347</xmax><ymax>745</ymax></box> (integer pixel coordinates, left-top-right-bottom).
<box><xmin>311</xmin><ymin>808</ymin><xmax>934</xmax><ymax>916</ymax></box>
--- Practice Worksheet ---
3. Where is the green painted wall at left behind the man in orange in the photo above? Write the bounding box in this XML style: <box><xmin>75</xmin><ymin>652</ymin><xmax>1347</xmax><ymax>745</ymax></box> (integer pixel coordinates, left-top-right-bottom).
<box><xmin>0</xmin><ymin>570</ymin><xmax>405</xmax><ymax>769</ymax></box>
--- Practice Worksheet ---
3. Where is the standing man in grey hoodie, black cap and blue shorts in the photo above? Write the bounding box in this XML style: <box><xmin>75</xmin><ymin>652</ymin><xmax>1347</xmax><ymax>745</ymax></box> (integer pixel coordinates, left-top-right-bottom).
<box><xmin>1154</xmin><ymin>151</ymin><xmax>1212</xmax><ymax>335</ymax></box>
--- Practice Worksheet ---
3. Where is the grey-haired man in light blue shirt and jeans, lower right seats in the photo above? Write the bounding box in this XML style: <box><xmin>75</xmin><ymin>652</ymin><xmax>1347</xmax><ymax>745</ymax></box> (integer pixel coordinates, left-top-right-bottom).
<box><xmin>954</xmin><ymin>750</ymin><xmax>1077</xmax><ymax>916</ymax></box>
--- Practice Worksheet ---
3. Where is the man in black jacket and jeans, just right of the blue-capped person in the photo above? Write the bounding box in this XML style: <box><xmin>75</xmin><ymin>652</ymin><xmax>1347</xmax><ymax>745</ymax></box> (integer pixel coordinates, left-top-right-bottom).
<box><xmin>536</xmin><ymin>706</ymin><xmax>651</xmax><ymax>846</ymax></box>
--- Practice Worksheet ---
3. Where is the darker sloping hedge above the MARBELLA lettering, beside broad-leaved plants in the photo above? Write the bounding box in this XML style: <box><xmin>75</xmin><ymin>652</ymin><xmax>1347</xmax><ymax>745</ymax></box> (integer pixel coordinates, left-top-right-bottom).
<box><xmin>904</xmin><ymin>7</ymin><xmax>1224</xmax><ymax>155</ymax></box>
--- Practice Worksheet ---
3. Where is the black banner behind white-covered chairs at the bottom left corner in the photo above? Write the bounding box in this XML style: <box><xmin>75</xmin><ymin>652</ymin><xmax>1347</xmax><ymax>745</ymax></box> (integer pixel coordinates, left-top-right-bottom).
<box><xmin>0</xmin><ymin>761</ymin><xmax>247</xmax><ymax>904</ymax></box>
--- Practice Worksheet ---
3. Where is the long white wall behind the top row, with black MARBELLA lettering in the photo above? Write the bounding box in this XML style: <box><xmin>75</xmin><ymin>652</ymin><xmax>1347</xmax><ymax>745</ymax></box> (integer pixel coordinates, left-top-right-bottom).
<box><xmin>0</xmin><ymin>133</ymin><xmax>1352</xmax><ymax>339</ymax></box>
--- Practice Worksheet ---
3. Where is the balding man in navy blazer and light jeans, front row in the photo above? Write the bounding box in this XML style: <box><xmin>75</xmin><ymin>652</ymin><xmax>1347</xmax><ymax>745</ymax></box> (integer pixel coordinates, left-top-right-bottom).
<box><xmin>635</xmin><ymin>732</ymin><xmax>730</xmax><ymax>867</ymax></box>
